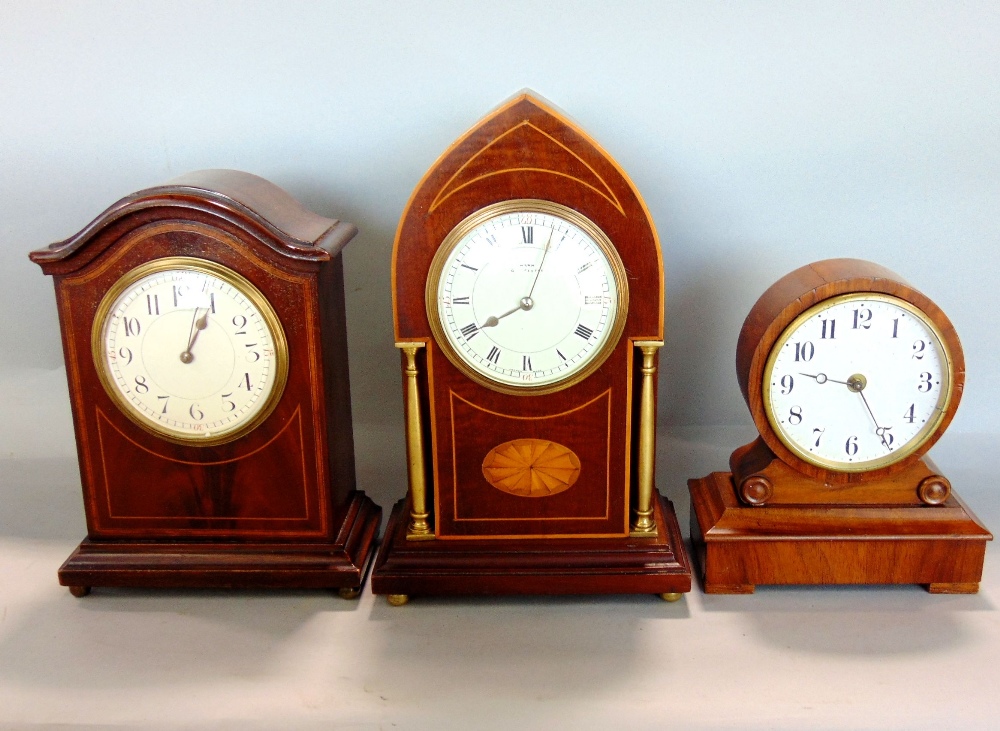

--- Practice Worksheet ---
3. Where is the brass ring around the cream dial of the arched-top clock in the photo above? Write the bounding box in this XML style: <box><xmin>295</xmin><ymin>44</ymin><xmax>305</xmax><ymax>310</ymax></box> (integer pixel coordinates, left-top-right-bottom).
<box><xmin>90</xmin><ymin>256</ymin><xmax>288</xmax><ymax>447</ymax></box>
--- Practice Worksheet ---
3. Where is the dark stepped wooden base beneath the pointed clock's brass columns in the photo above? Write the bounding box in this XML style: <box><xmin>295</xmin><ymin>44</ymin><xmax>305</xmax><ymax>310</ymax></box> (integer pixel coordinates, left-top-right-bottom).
<box><xmin>371</xmin><ymin>491</ymin><xmax>691</xmax><ymax>606</ymax></box>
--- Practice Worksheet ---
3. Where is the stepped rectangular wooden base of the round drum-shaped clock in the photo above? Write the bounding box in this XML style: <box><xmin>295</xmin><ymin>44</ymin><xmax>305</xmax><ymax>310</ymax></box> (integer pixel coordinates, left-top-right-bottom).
<box><xmin>688</xmin><ymin>472</ymin><xmax>993</xmax><ymax>594</ymax></box>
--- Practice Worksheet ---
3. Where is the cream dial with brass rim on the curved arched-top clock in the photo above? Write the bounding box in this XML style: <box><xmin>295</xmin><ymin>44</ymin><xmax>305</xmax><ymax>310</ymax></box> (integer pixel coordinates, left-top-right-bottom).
<box><xmin>93</xmin><ymin>257</ymin><xmax>288</xmax><ymax>445</ymax></box>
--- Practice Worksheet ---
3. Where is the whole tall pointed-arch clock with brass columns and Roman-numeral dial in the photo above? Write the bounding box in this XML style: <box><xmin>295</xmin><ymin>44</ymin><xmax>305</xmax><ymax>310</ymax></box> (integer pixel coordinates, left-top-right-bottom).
<box><xmin>372</xmin><ymin>93</ymin><xmax>691</xmax><ymax>604</ymax></box>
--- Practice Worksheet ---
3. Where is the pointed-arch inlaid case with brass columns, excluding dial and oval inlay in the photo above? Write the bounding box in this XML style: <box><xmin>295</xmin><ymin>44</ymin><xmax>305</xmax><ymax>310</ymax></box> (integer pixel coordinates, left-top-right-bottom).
<box><xmin>372</xmin><ymin>93</ymin><xmax>691</xmax><ymax>603</ymax></box>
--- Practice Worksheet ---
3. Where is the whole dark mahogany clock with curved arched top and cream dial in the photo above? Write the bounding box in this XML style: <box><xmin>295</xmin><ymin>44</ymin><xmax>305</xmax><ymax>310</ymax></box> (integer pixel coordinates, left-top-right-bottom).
<box><xmin>31</xmin><ymin>170</ymin><xmax>381</xmax><ymax>597</ymax></box>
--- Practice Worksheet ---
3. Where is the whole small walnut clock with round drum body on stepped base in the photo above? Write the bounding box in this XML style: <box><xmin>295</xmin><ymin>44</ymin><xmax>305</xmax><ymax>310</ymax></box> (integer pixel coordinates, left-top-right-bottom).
<box><xmin>688</xmin><ymin>259</ymin><xmax>992</xmax><ymax>593</ymax></box>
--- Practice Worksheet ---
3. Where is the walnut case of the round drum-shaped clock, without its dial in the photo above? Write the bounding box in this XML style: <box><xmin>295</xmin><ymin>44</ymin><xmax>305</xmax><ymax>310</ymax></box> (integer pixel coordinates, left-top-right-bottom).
<box><xmin>688</xmin><ymin>259</ymin><xmax>992</xmax><ymax>594</ymax></box>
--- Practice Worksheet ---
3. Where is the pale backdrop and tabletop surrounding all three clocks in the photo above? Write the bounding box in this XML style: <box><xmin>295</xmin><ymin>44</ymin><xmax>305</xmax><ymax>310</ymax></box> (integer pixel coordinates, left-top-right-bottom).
<box><xmin>0</xmin><ymin>0</ymin><xmax>1000</xmax><ymax>731</ymax></box>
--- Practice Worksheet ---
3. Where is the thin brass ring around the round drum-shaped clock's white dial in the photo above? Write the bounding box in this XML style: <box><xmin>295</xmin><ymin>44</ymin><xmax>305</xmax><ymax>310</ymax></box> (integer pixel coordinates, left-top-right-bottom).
<box><xmin>761</xmin><ymin>292</ymin><xmax>955</xmax><ymax>473</ymax></box>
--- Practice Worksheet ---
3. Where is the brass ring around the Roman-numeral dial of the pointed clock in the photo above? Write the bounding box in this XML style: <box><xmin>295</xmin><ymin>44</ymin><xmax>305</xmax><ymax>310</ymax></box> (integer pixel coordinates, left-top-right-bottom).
<box><xmin>424</xmin><ymin>198</ymin><xmax>628</xmax><ymax>396</ymax></box>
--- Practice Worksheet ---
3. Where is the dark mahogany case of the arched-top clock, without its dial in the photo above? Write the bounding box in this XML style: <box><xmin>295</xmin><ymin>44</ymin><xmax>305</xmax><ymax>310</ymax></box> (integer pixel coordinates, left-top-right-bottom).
<box><xmin>31</xmin><ymin>170</ymin><xmax>381</xmax><ymax>597</ymax></box>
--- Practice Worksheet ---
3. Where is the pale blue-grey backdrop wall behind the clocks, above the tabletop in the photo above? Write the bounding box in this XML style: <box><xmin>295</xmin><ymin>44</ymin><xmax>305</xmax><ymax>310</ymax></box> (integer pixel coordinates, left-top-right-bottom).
<box><xmin>0</xmin><ymin>1</ymin><xmax>1000</xmax><ymax>484</ymax></box>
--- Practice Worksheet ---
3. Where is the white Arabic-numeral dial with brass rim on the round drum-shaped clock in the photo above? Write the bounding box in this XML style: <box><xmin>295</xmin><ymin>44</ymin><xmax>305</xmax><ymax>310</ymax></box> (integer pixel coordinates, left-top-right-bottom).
<box><xmin>763</xmin><ymin>292</ymin><xmax>952</xmax><ymax>472</ymax></box>
